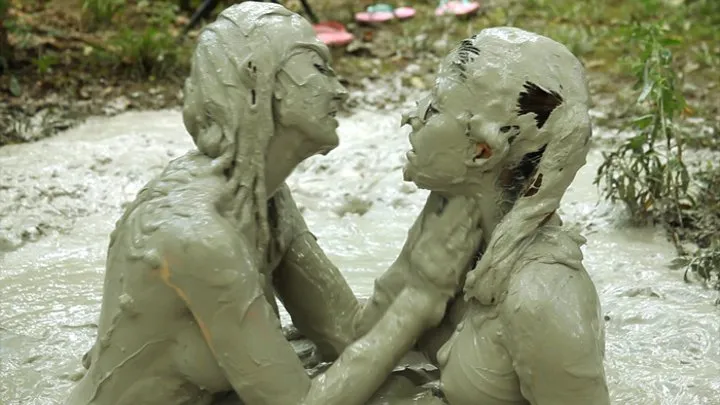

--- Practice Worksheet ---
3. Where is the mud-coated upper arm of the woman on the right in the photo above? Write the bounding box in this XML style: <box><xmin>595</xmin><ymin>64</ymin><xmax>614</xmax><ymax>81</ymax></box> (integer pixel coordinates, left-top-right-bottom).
<box><xmin>502</xmin><ymin>263</ymin><xmax>610</xmax><ymax>405</ymax></box>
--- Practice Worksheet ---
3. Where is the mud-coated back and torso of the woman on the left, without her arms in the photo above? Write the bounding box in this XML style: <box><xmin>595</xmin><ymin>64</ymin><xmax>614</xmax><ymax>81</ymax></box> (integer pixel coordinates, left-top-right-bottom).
<box><xmin>66</xmin><ymin>152</ymin><xmax>312</xmax><ymax>405</ymax></box>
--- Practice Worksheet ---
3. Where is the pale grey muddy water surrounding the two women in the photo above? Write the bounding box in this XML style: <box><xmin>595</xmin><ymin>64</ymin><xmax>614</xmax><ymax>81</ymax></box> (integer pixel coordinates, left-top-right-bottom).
<box><xmin>0</xmin><ymin>111</ymin><xmax>720</xmax><ymax>405</ymax></box>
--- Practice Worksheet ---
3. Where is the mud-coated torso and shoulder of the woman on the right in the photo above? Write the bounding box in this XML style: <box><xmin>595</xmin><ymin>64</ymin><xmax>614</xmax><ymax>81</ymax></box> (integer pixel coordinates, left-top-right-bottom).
<box><xmin>420</xmin><ymin>225</ymin><xmax>609</xmax><ymax>405</ymax></box>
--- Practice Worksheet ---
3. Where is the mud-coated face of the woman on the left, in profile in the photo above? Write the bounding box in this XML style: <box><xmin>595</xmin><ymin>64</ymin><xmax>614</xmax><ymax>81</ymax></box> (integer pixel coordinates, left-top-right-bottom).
<box><xmin>275</xmin><ymin>48</ymin><xmax>347</xmax><ymax>154</ymax></box>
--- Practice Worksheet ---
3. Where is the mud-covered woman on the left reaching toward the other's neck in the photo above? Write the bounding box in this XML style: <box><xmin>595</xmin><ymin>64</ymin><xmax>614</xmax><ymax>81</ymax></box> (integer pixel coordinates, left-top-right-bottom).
<box><xmin>66</xmin><ymin>2</ymin><xmax>480</xmax><ymax>405</ymax></box>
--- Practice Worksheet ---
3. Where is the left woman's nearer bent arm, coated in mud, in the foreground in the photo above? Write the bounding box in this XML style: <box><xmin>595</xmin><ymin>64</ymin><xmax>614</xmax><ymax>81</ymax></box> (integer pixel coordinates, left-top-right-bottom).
<box><xmin>162</xmin><ymin>224</ymin><xmax>456</xmax><ymax>405</ymax></box>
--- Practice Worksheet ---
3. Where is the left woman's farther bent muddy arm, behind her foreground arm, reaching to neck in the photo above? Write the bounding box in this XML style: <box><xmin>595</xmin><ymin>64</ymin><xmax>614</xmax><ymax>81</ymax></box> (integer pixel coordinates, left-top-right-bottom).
<box><xmin>274</xmin><ymin>189</ymin><xmax>478</xmax><ymax>350</ymax></box>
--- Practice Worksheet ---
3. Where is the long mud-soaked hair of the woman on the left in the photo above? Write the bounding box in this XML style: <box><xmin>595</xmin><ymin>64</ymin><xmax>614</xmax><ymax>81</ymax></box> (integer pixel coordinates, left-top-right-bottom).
<box><xmin>183</xmin><ymin>2</ymin><xmax>328</xmax><ymax>261</ymax></box>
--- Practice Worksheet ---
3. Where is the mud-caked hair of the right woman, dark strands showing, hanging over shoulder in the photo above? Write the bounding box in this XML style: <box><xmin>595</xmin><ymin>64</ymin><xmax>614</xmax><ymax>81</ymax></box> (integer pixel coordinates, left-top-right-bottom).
<box><xmin>458</xmin><ymin>27</ymin><xmax>591</xmax><ymax>305</ymax></box>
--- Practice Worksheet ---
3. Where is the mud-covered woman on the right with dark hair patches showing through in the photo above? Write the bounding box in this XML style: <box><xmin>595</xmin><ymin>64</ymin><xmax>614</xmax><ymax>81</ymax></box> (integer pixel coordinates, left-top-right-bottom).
<box><xmin>357</xmin><ymin>27</ymin><xmax>610</xmax><ymax>405</ymax></box>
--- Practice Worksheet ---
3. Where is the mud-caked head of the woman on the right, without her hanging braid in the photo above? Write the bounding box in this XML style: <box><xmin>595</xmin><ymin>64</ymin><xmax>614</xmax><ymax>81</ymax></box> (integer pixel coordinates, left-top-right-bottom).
<box><xmin>403</xmin><ymin>27</ymin><xmax>586</xmax><ymax>200</ymax></box>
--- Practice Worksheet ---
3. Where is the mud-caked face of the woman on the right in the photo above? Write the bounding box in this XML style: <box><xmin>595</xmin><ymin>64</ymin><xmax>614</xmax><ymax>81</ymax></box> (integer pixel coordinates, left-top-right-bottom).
<box><xmin>403</xmin><ymin>76</ymin><xmax>518</xmax><ymax>194</ymax></box>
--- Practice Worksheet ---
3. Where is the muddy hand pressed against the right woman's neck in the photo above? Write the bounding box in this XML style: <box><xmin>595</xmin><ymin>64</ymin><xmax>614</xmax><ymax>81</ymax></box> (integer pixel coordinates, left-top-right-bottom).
<box><xmin>405</xmin><ymin>193</ymin><xmax>482</xmax><ymax>299</ymax></box>
